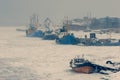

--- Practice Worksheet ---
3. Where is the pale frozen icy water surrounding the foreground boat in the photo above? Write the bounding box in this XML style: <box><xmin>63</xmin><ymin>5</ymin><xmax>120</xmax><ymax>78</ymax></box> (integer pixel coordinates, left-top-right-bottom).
<box><xmin>0</xmin><ymin>27</ymin><xmax>120</xmax><ymax>80</ymax></box>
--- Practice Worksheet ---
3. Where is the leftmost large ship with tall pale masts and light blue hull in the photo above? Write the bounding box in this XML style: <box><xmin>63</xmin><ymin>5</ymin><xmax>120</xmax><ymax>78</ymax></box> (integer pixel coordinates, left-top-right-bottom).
<box><xmin>26</xmin><ymin>14</ymin><xmax>44</xmax><ymax>37</ymax></box>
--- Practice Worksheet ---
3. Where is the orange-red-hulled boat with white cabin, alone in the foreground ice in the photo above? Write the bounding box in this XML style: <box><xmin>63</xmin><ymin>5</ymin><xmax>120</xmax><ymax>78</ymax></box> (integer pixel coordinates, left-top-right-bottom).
<box><xmin>70</xmin><ymin>58</ymin><xmax>94</xmax><ymax>74</ymax></box>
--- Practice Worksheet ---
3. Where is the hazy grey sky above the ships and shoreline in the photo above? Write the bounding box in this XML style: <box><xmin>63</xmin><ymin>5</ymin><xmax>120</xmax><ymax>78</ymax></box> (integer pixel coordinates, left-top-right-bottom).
<box><xmin>0</xmin><ymin>0</ymin><xmax>120</xmax><ymax>26</ymax></box>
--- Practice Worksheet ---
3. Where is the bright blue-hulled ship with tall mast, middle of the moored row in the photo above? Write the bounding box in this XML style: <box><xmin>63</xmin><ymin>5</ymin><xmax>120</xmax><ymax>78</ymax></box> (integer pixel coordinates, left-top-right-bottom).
<box><xmin>56</xmin><ymin>17</ymin><xmax>79</xmax><ymax>45</ymax></box>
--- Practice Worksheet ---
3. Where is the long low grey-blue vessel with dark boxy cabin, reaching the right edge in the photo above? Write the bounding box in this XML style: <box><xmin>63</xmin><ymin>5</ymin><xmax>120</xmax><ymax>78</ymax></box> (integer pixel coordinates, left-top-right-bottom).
<box><xmin>79</xmin><ymin>33</ymin><xmax>120</xmax><ymax>46</ymax></box>
